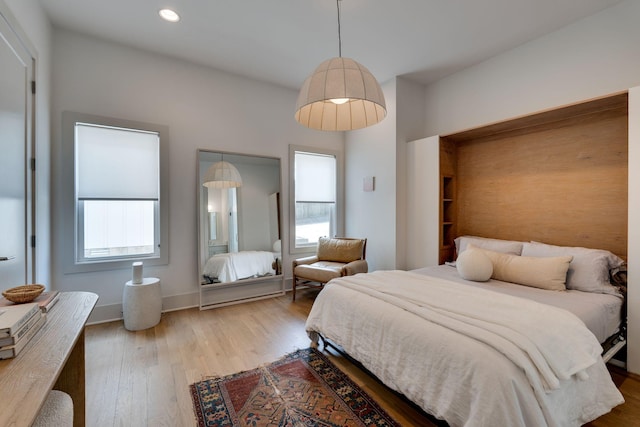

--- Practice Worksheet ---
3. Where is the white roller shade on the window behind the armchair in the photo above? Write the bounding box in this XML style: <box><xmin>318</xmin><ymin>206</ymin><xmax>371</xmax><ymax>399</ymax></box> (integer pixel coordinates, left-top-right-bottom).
<box><xmin>295</xmin><ymin>152</ymin><xmax>336</xmax><ymax>203</ymax></box>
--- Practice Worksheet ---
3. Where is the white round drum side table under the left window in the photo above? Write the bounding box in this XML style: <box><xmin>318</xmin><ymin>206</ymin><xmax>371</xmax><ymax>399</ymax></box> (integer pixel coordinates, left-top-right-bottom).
<box><xmin>122</xmin><ymin>277</ymin><xmax>162</xmax><ymax>331</ymax></box>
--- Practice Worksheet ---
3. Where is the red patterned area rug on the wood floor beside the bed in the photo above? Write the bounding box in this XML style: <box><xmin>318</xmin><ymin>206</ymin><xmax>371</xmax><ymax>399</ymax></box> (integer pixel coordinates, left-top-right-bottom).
<box><xmin>190</xmin><ymin>348</ymin><xmax>399</xmax><ymax>427</ymax></box>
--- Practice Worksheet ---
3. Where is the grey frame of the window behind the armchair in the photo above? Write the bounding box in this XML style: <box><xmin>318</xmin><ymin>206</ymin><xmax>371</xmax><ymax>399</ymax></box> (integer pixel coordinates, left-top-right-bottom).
<box><xmin>289</xmin><ymin>145</ymin><xmax>345</xmax><ymax>254</ymax></box>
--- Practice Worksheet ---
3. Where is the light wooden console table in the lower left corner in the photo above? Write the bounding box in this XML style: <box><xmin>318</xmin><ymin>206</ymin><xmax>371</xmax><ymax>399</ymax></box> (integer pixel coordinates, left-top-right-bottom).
<box><xmin>0</xmin><ymin>292</ymin><xmax>98</xmax><ymax>427</ymax></box>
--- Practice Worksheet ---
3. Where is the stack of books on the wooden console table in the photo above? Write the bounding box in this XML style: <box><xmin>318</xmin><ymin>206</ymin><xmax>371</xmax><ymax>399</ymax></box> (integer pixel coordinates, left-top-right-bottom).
<box><xmin>0</xmin><ymin>291</ymin><xmax>59</xmax><ymax>360</ymax></box>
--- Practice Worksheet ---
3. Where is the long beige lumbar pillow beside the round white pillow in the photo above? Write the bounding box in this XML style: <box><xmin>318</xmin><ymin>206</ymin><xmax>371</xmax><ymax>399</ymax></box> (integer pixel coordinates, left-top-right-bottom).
<box><xmin>467</xmin><ymin>245</ymin><xmax>572</xmax><ymax>291</ymax></box>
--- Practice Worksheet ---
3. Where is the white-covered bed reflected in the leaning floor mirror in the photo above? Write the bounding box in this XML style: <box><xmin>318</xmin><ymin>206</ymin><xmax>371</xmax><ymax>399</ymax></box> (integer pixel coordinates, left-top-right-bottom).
<box><xmin>202</xmin><ymin>251</ymin><xmax>276</xmax><ymax>284</ymax></box>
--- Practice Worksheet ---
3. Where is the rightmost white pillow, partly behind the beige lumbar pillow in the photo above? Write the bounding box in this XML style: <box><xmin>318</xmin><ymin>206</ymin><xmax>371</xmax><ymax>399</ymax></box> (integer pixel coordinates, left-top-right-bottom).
<box><xmin>522</xmin><ymin>242</ymin><xmax>624</xmax><ymax>295</ymax></box>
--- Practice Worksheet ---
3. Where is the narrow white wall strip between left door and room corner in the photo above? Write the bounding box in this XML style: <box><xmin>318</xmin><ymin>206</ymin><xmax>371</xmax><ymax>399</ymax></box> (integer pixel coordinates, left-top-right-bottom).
<box><xmin>0</xmin><ymin>0</ymin><xmax>52</xmax><ymax>286</ymax></box>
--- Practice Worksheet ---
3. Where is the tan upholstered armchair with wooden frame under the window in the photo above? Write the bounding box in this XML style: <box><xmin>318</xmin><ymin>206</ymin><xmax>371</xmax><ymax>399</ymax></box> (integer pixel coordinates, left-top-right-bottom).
<box><xmin>293</xmin><ymin>237</ymin><xmax>369</xmax><ymax>301</ymax></box>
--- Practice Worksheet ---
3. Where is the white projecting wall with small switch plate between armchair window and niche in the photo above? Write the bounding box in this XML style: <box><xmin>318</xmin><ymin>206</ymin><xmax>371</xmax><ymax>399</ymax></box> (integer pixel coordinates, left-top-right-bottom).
<box><xmin>345</xmin><ymin>78</ymin><xmax>425</xmax><ymax>271</ymax></box>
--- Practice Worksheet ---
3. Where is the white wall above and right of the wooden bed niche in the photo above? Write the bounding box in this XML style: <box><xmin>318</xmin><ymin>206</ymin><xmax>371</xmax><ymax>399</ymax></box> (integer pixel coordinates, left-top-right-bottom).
<box><xmin>425</xmin><ymin>0</ymin><xmax>640</xmax><ymax>373</ymax></box>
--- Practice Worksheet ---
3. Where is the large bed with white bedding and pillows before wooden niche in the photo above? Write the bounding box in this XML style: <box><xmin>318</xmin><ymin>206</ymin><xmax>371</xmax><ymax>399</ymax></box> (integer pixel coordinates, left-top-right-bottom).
<box><xmin>306</xmin><ymin>238</ymin><xmax>624</xmax><ymax>427</ymax></box>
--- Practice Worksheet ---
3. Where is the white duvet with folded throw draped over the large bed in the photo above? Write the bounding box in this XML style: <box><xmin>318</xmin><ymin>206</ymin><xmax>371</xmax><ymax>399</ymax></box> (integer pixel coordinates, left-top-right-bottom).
<box><xmin>306</xmin><ymin>271</ymin><xmax>623</xmax><ymax>426</ymax></box>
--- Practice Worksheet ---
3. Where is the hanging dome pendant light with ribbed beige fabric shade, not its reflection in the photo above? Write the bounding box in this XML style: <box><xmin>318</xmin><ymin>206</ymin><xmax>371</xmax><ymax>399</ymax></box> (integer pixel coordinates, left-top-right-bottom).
<box><xmin>295</xmin><ymin>0</ymin><xmax>387</xmax><ymax>131</ymax></box>
